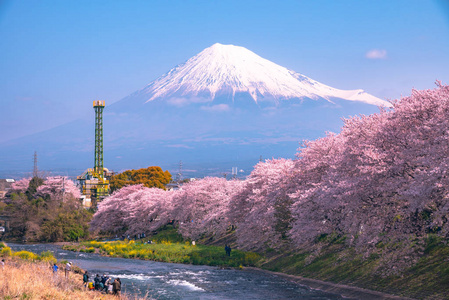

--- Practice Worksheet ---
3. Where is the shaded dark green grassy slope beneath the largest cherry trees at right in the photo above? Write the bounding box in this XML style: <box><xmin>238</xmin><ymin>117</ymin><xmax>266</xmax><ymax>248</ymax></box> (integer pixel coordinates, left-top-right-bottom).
<box><xmin>261</xmin><ymin>238</ymin><xmax>449</xmax><ymax>300</ymax></box>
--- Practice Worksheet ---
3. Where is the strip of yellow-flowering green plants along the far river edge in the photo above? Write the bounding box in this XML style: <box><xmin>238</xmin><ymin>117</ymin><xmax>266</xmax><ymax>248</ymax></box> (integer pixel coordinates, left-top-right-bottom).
<box><xmin>76</xmin><ymin>240</ymin><xmax>261</xmax><ymax>267</ymax></box>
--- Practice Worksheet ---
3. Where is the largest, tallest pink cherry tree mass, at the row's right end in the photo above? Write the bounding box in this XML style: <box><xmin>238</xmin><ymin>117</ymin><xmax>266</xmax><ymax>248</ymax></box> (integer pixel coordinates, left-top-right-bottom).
<box><xmin>291</xmin><ymin>85</ymin><xmax>449</xmax><ymax>254</ymax></box>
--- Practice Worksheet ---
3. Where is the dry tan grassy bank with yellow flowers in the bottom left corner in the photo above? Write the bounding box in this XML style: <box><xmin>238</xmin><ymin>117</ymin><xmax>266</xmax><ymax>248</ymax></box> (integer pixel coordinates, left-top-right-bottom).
<box><xmin>0</xmin><ymin>243</ymin><xmax>139</xmax><ymax>300</ymax></box>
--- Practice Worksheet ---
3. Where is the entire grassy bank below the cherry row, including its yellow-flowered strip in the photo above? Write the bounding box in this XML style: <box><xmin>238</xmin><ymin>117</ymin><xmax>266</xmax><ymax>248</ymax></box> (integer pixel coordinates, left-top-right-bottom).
<box><xmin>60</xmin><ymin>228</ymin><xmax>449</xmax><ymax>300</ymax></box>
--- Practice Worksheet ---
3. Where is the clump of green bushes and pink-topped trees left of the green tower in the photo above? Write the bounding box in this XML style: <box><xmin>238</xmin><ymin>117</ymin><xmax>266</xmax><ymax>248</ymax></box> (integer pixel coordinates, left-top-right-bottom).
<box><xmin>0</xmin><ymin>176</ymin><xmax>92</xmax><ymax>242</ymax></box>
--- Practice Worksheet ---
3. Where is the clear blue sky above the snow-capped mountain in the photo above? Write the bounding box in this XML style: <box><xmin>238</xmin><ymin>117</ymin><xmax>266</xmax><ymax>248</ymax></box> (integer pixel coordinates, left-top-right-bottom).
<box><xmin>0</xmin><ymin>0</ymin><xmax>449</xmax><ymax>141</ymax></box>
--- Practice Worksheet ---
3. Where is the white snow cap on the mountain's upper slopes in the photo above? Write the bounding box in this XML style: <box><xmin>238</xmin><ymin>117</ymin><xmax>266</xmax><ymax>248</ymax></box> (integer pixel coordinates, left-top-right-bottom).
<box><xmin>139</xmin><ymin>43</ymin><xmax>391</xmax><ymax>107</ymax></box>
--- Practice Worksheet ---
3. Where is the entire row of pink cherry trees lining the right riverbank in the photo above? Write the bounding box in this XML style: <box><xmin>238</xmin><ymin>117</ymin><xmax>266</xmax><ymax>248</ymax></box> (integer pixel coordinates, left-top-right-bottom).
<box><xmin>91</xmin><ymin>83</ymin><xmax>449</xmax><ymax>254</ymax></box>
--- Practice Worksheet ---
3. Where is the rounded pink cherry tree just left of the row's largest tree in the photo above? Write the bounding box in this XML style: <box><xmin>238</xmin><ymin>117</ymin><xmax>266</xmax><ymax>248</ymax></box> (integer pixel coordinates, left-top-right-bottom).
<box><xmin>229</xmin><ymin>159</ymin><xmax>294</xmax><ymax>250</ymax></box>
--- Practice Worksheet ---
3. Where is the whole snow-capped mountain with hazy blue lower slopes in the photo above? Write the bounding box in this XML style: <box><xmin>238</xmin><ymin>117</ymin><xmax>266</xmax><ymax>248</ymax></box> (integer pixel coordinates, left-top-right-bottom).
<box><xmin>0</xmin><ymin>44</ymin><xmax>390</xmax><ymax>176</ymax></box>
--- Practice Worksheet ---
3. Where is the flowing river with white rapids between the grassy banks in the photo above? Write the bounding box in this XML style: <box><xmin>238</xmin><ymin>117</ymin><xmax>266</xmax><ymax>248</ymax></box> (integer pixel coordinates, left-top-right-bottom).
<box><xmin>8</xmin><ymin>243</ymin><xmax>343</xmax><ymax>300</ymax></box>
